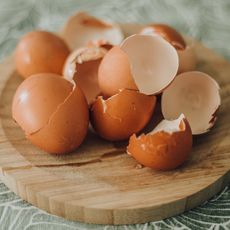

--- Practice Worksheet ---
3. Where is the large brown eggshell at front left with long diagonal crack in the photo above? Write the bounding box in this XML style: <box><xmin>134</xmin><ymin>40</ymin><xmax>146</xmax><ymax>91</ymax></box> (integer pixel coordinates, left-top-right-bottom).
<box><xmin>12</xmin><ymin>73</ymin><xmax>89</xmax><ymax>153</ymax></box>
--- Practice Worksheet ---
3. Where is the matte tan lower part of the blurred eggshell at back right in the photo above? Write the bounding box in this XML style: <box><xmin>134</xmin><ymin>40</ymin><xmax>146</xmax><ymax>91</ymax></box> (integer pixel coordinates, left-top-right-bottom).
<box><xmin>177</xmin><ymin>40</ymin><xmax>197</xmax><ymax>73</ymax></box>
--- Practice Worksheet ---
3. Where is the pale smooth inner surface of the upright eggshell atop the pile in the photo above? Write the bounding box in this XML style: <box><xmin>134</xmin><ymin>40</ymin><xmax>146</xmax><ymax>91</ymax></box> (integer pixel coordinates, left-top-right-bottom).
<box><xmin>121</xmin><ymin>35</ymin><xmax>179</xmax><ymax>95</ymax></box>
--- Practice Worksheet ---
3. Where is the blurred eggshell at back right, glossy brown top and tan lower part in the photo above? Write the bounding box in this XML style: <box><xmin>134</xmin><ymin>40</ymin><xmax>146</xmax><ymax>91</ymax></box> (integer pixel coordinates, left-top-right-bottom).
<box><xmin>140</xmin><ymin>24</ymin><xmax>197</xmax><ymax>73</ymax></box>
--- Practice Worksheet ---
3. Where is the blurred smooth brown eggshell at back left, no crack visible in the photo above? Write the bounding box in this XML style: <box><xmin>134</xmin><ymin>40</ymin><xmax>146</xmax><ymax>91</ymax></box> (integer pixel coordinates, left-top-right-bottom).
<box><xmin>15</xmin><ymin>31</ymin><xmax>69</xmax><ymax>78</ymax></box>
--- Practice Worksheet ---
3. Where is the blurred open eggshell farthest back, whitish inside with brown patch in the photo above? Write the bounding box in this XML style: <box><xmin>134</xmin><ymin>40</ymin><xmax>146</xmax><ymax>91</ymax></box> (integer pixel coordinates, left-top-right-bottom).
<box><xmin>62</xmin><ymin>12</ymin><xmax>124</xmax><ymax>50</ymax></box>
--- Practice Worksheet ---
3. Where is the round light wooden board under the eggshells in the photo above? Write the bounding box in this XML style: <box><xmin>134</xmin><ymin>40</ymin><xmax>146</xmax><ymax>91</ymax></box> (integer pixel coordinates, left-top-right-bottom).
<box><xmin>0</xmin><ymin>26</ymin><xmax>230</xmax><ymax>224</ymax></box>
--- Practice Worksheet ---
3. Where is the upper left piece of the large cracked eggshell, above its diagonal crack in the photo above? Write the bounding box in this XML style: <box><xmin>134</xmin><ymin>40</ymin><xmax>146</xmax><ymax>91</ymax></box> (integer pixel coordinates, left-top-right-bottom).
<box><xmin>12</xmin><ymin>73</ymin><xmax>73</xmax><ymax>134</ymax></box>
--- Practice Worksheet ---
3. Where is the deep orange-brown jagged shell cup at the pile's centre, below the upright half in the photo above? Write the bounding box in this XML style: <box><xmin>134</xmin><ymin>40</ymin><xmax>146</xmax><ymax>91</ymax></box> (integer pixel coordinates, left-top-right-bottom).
<box><xmin>91</xmin><ymin>89</ymin><xmax>156</xmax><ymax>141</ymax></box>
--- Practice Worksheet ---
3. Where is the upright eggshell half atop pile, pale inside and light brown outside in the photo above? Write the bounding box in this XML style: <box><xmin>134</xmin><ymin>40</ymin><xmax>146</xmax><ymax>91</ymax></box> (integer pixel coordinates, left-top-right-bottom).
<box><xmin>98</xmin><ymin>35</ymin><xmax>179</xmax><ymax>96</ymax></box>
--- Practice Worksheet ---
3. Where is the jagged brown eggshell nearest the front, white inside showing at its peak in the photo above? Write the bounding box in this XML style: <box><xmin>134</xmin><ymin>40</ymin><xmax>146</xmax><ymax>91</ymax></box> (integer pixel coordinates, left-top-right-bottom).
<box><xmin>127</xmin><ymin>114</ymin><xmax>192</xmax><ymax>170</ymax></box>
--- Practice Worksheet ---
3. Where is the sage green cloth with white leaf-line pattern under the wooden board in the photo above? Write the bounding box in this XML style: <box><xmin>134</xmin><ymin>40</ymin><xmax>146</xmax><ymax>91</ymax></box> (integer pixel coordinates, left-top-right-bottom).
<box><xmin>0</xmin><ymin>0</ymin><xmax>230</xmax><ymax>230</ymax></box>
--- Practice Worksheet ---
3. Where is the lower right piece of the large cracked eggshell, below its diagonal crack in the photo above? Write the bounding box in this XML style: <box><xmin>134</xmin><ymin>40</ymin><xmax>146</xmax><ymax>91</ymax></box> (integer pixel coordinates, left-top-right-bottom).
<box><xmin>27</xmin><ymin>83</ymin><xmax>89</xmax><ymax>154</ymax></box>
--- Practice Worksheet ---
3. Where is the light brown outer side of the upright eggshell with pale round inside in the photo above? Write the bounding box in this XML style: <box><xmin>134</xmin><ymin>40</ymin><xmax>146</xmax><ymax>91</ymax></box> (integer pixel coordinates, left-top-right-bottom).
<box><xmin>98</xmin><ymin>46</ymin><xmax>137</xmax><ymax>96</ymax></box>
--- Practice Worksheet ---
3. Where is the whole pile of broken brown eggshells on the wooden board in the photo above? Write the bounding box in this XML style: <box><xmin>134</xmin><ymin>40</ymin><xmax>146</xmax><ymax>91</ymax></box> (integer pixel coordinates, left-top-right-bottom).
<box><xmin>12</xmin><ymin>12</ymin><xmax>220</xmax><ymax>170</ymax></box>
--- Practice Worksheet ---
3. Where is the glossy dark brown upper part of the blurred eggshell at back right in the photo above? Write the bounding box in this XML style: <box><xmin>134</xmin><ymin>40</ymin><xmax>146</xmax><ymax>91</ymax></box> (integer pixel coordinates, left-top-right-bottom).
<box><xmin>140</xmin><ymin>24</ymin><xmax>186</xmax><ymax>50</ymax></box>
